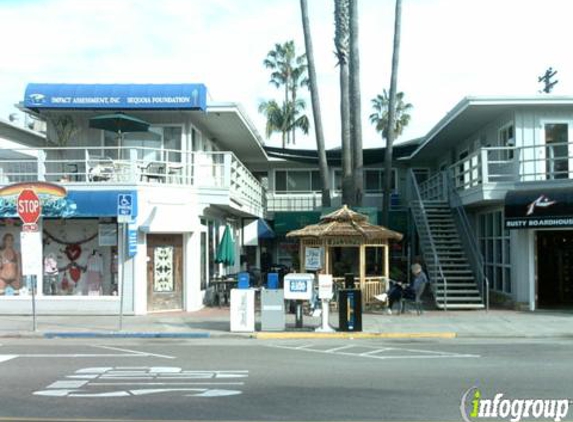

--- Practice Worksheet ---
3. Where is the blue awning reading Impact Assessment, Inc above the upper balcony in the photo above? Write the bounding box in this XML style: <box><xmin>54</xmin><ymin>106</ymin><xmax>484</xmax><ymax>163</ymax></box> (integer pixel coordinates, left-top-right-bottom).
<box><xmin>24</xmin><ymin>83</ymin><xmax>207</xmax><ymax>111</ymax></box>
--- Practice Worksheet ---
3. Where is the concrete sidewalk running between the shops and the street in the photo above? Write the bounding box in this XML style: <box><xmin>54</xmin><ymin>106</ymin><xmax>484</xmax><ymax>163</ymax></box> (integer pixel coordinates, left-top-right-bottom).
<box><xmin>0</xmin><ymin>308</ymin><xmax>573</xmax><ymax>338</ymax></box>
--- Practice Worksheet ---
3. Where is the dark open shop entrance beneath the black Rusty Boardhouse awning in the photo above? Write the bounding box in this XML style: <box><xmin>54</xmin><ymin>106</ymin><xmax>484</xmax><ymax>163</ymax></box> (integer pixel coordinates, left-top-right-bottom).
<box><xmin>537</xmin><ymin>230</ymin><xmax>573</xmax><ymax>308</ymax></box>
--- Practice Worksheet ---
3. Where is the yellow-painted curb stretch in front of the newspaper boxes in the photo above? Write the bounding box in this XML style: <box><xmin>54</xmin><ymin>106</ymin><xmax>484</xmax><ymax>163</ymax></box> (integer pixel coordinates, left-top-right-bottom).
<box><xmin>253</xmin><ymin>332</ymin><xmax>458</xmax><ymax>340</ymax></box>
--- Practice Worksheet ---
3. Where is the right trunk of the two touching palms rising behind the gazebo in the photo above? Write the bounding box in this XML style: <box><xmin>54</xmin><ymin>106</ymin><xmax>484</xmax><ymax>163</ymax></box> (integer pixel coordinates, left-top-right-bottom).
<box><xmin>349</xmin><ymin>0</ymin><xmax>364</xmax><ymax>206</ymax></box>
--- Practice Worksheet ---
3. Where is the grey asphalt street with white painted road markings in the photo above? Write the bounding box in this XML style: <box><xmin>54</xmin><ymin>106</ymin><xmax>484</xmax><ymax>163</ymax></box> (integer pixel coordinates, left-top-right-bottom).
<box><xmin>0</xmin><ymin>339</ymin><xmax>573</xmax><ymax>421</ymax></box>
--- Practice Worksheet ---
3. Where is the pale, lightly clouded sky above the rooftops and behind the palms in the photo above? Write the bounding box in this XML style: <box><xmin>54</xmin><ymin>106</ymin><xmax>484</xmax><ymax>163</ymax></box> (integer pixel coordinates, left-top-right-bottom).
<box><xmin>0</xmin><ymin>0</ymin><xmax>573</xmax><ymax>149</ymax></box>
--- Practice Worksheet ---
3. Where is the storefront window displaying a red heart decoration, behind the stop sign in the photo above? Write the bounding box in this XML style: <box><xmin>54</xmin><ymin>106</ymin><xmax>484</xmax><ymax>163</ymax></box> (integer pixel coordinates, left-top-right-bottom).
<box><xmin>41</xmin><ymin>219</ymin><xmax>118</xmax><ymax>296</ymax></box>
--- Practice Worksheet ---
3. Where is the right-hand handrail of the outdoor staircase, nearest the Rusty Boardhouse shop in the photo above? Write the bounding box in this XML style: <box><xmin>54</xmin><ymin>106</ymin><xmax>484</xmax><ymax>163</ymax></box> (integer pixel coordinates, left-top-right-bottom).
<box><xmin>446</xmin><ymin>169</ymin><xmax>489</xmax><ymax>312</ymax></box>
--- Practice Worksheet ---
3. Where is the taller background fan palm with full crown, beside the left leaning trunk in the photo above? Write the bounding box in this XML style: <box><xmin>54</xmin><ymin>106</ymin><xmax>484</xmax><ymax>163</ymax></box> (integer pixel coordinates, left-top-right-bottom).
<box><xmin>263</xmin><ymin>40</ymin><xmax>308</xmax><ymax>148</ymax></box>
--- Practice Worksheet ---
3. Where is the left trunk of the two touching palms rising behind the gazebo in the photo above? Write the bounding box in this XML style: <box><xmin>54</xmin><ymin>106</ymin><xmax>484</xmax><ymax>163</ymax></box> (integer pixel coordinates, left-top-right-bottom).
<box><xmin>334</xmin><ymin>0</ymin><xmax>355</xmax><ymax>206</ymax></box>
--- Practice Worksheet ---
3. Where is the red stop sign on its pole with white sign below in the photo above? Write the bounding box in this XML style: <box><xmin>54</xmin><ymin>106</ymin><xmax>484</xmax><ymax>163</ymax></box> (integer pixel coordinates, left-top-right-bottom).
<box><xmin>16</xmin><ymin>189</ymin><xmax>42</xmax><ymax>331</ymax></box>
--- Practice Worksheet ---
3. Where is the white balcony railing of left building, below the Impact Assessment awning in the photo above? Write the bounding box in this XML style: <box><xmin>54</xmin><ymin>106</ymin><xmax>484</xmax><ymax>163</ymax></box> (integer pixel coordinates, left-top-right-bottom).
<box><xmin>0</xmin><ymin>147</ymin><xmax>265</xmax><ymax>213</ymax></box>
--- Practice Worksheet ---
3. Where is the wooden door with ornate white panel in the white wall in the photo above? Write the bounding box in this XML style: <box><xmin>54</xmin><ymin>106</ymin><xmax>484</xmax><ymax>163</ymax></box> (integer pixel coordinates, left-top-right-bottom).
<box><xmin>147</xmin><ymin>234</ymin><xmax>183</xmax><ymax>311</ymax></box>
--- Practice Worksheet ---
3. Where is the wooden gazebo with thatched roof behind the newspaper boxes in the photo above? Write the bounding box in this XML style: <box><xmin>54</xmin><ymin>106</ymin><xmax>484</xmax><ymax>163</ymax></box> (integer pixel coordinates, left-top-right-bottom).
<box><xmin>286</xmin><ymin>205</ymin><xmax>403</xmax><ymax>305</ymax></box>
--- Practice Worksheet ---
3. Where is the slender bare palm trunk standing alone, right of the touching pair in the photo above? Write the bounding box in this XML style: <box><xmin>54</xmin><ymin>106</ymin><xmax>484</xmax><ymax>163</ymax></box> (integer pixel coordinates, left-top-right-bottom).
<box><xmin>382</xmin><ymin>0</ymin><xmax>402</xmax><ymax>226</ymax></box>
